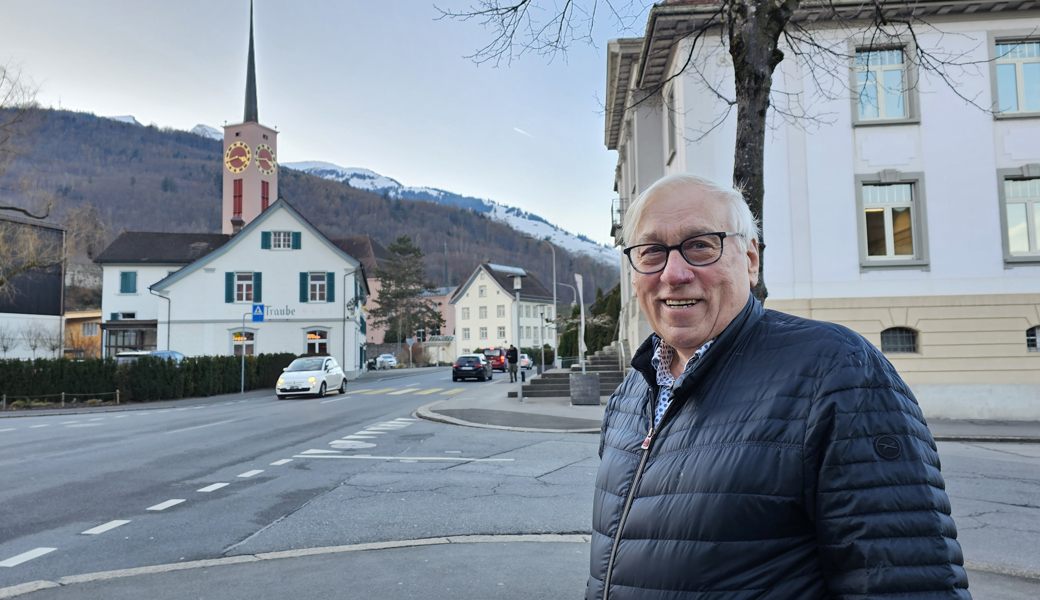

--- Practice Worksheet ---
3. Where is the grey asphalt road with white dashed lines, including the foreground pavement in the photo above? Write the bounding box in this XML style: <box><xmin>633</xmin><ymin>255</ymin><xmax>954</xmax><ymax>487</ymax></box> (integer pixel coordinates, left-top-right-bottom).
<box><xmin>0</xmin><ymin>369</ymin><xmax>1040</xmax><ymax>600</ymax></box>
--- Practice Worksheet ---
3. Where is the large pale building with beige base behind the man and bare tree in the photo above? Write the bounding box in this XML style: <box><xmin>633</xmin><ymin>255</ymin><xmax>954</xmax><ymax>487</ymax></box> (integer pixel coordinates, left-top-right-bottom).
<box><xmin>605</xmin><ymin>0</ymin><xmax>1040</xmax><ymax>419</ymax></box>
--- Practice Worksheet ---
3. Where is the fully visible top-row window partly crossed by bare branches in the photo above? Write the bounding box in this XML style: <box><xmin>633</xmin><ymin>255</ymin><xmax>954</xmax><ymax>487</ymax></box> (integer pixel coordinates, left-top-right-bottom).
<box><xmin>856</xmin><ymin>48</ymin><xmax>908</xmax><ymax>121</ymax></box>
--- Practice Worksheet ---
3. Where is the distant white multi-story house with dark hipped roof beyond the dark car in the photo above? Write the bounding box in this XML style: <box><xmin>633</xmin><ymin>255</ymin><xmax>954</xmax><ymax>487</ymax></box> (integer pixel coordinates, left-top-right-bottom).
<box><xmin>449</xmin><ymin>263</ymin><xmax>556</xmax><ymax>355</ymax></box>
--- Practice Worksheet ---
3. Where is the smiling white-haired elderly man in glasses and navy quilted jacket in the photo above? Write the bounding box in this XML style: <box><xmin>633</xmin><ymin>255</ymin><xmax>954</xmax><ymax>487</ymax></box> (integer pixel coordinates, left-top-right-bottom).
<box><xmin>587</xmin><ymin>175</ymin><xmax>970</xmax><ymax>600</ymax></box>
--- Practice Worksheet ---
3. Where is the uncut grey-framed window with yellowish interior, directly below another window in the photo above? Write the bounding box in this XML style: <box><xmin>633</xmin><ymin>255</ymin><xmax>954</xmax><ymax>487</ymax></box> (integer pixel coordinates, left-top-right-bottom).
<box><xmin>861</xmin><ymin>183</ymin><xmax>916</xmax><ymax>260</ymax></box>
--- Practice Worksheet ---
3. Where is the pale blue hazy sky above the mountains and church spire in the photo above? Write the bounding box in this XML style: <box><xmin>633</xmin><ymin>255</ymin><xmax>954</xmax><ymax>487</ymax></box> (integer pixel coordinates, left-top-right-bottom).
<box><xmin>0</xmin><ymin>0</ymin><xmax>646</xmax><ymax>242</ymax></box>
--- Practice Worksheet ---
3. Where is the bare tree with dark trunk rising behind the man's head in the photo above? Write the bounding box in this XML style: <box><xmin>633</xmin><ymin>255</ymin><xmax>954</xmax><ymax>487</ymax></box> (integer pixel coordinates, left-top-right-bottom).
<box><xmin>441</xmin><ymin>0</ymin><xmax>1006</xmax><ymax>299</ymax></box>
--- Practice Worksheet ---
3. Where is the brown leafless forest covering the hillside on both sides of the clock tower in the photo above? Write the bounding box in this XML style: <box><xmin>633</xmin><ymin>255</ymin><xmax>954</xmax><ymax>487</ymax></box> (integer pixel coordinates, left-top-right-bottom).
<box><xmin>0</xmin><ymin>109</ymin><xmax>619</xmax><ymax>295</ymax></box>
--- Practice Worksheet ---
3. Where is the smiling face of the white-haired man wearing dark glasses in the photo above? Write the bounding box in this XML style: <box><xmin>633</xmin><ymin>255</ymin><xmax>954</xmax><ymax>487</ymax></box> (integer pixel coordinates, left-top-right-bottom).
<box><xmin>631</xmin><ymin>188</ymin><xmax>758</xmax><ymax>365</ymax></box>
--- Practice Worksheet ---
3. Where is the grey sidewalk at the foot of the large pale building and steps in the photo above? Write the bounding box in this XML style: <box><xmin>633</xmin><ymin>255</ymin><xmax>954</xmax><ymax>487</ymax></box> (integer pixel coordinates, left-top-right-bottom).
<box><xmin>416</xmin><ymin>373</ymin><xmax>1040</xmax><ymax>443</ymax></box>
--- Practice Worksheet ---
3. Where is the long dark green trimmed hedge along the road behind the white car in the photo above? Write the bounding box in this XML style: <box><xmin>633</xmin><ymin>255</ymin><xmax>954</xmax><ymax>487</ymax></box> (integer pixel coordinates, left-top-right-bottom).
<box><xmin>0</xmin><ymin>354</ymin><xmax>296</xmax><ymax>401</ymax></box>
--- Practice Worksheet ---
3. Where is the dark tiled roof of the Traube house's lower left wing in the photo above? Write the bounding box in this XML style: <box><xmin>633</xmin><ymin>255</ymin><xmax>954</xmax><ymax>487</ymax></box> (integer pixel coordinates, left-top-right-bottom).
<box><xmin>94</xmin><ymin>231</ymin><xmax>231</xmax><ymax>264</ymax></box>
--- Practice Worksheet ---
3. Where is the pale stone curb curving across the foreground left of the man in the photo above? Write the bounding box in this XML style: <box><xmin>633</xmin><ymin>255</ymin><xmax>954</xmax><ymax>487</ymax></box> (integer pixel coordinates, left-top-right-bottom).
<box><xmin>0</xmin><ymin>533</ymin><xmax>592</xmax><ymax>599</ymax></box>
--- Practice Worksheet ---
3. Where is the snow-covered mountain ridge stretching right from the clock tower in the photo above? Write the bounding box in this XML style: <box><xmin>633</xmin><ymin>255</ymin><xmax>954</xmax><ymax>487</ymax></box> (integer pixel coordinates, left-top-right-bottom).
<box><xmin>282</xmin><ymin>161</ymin><xmax>618</xmax><ymax>264</ymax></box>
